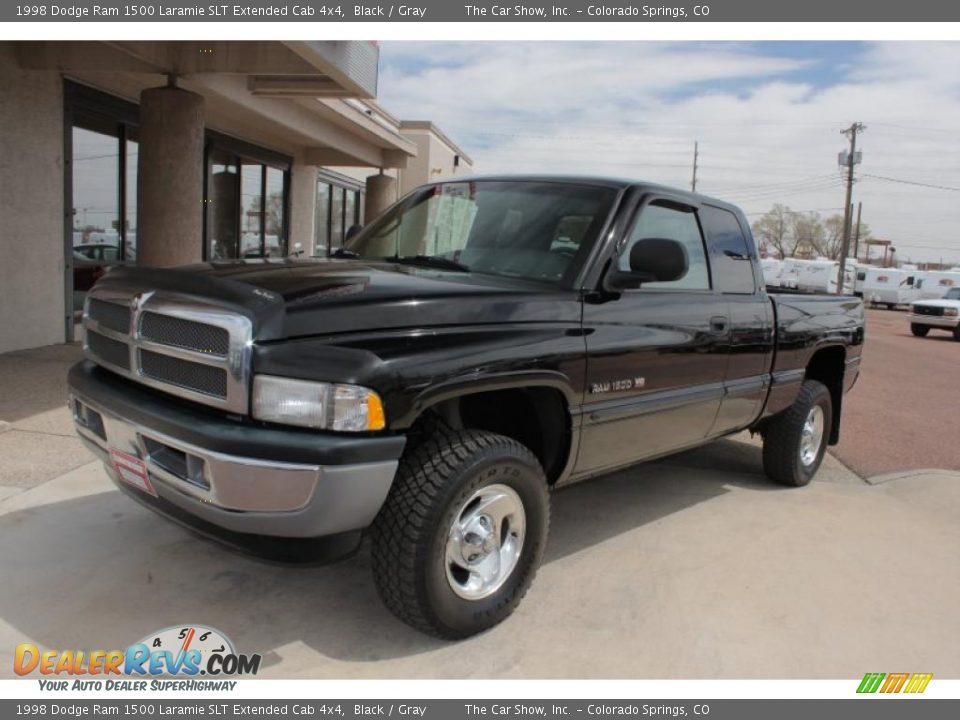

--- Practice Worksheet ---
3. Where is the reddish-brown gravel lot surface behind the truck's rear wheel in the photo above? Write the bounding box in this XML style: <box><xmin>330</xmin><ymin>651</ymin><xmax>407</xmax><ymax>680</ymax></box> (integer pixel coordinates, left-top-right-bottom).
<box><xmin>832</xmin><ymin>309</ymin><xmax>960</xmax><ymax>477</ymax></box>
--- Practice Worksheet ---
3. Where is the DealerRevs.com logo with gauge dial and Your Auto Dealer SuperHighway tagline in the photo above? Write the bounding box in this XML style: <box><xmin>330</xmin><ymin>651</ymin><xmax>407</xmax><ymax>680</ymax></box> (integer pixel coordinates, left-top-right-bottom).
<box><xmin>13</xmin><ymin>625</ymin><xmax>261</xmax><ymax>690</ymax></box>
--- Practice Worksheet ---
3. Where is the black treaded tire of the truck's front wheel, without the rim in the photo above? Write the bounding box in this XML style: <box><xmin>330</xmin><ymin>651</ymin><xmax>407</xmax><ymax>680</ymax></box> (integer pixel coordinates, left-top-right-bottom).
<box><xmin>371</xmin><ymin>423</ymin><xmax>550</xmax><ymax>639</ymax></box>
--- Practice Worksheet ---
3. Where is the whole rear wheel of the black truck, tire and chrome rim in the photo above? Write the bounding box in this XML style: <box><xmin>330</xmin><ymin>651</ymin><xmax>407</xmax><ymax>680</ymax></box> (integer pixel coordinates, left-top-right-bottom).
<box><xmin>763</xmin><ymin>380</ymin><xmax>833</xmax><ymax>487</ymax></box>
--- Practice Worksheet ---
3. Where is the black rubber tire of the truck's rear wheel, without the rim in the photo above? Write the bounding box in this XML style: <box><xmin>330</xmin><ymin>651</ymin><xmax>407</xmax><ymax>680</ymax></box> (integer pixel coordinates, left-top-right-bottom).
<box><xmin>763</xmin><ymin>380</ymin><xmax>833</xmax><ymax>487</ymax></box>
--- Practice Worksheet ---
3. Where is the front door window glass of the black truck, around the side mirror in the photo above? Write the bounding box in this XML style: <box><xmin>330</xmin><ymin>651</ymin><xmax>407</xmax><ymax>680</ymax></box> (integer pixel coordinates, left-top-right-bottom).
<box><xmin>617</xmin><ymin>200</ymin><xmax>710</xmax><ymax>290</ymax></box>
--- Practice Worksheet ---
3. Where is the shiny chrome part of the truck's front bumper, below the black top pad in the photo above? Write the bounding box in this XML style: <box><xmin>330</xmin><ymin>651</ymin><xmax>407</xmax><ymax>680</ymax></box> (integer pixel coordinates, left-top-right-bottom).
<box><xmin>70</xmin><ymin>389</ymin><xmax>398</xmax><ymax>538</ymax></box>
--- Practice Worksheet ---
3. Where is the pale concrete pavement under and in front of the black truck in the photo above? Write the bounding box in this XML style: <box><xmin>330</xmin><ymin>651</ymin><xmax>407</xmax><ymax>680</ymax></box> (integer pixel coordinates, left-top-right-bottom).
<box><xmin>0</xmin><ymin>440</ymin><xmax>960</xmax><ymax>678</ymax></box>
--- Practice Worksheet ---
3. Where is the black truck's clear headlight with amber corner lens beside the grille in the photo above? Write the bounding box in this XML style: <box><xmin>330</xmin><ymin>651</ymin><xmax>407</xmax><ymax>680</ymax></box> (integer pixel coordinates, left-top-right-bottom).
<box><xmin>253</xmin><ymin>375</ymin><xmax>387</xmax><ymax>432</ymax></box>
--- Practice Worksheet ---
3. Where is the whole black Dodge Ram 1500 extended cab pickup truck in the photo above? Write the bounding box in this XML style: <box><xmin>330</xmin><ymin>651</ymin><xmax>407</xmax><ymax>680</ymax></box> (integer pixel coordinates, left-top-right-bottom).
<box><xmin>69</xmin><ymin>177</ymin><xmax>864</xmax><ymax>638</ymax></box>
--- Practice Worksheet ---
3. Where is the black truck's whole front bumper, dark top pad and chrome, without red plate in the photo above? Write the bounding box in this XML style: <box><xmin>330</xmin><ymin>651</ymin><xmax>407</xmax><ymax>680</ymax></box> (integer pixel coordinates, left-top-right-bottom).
<box><xmin>68</xmin><ymin>362</ymin><xmax>406</xmax><ymax>544</ymax></box>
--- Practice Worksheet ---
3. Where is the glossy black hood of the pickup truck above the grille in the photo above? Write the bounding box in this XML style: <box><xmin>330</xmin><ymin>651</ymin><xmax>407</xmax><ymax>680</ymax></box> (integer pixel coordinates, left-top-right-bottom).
<box><xmin>99</xmin><ymin>259</ymin><xmax>570</xmax><ymax>342</ymax></box>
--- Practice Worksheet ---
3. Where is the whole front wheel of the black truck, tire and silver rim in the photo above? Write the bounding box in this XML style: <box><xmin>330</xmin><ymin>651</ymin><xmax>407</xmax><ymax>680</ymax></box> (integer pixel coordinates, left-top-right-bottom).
<box><xmin>371</xmin><ymin>425</ymin><xmax>550</xmax><ymax>639</ymax></box>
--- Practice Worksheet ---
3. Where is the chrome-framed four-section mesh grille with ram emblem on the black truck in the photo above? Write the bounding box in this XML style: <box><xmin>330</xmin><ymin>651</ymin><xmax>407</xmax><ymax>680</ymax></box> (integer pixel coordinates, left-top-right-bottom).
<box><xmin>83</xmin><ymin>287</ymin><xmax>253</xmax><ymax>414</ymax></box>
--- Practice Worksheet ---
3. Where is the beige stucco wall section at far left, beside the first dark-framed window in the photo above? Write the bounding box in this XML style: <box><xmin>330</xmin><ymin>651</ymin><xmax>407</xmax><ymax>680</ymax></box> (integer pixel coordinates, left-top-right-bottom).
<box><xmin>0</xmin><ymin>43</ymin><xmax>65</xmax><ymax>352</ymax></box>
